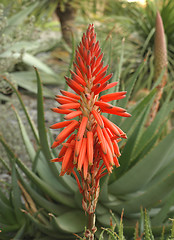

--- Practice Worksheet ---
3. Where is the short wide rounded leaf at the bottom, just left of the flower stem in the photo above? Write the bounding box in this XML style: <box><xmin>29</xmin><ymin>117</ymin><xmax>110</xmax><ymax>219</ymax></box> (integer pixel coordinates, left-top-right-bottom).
<box><xmin>54</xmin><ymin>210</ymin><xmax>86</xmax><ymax>233</ymax></box>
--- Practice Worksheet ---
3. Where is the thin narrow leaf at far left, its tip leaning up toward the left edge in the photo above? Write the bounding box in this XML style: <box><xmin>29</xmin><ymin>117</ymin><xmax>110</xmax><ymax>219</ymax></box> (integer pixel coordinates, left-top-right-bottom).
<box><xmin>1</xmin><ymin>78</ymin><xmax>39</xmax><ymax>143</ymax></box>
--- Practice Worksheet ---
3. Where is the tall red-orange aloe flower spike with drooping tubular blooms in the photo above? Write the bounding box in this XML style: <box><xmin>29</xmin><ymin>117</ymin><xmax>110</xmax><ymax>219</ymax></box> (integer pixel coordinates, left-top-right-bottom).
<box><xmin>51</xmin><ymin>25</ymin><xmax>130</xmax><ymax>237</ymax></box>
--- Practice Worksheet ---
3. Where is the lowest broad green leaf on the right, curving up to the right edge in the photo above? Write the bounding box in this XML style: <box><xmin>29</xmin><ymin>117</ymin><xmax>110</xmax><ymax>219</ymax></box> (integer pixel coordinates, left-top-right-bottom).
<box><xmin>104</xmin><ymin>173</ymin><xmax>174</xmax><ymax>214</ymax></box>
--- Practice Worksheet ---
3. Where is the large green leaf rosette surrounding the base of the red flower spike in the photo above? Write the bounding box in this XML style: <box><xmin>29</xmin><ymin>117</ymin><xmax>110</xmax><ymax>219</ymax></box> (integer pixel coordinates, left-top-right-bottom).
<box><xmin>0</xmin><ymin>27</ymin><xmax>174</xmax><ymax>239</ymax></box>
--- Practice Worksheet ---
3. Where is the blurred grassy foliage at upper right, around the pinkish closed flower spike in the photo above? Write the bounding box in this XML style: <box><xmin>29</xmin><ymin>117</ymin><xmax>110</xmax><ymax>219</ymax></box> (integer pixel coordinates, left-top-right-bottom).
<box><xmin>94</xmin><ymin>0</ymin><xmax>174</xmax><ymax>96</ymax></box>
